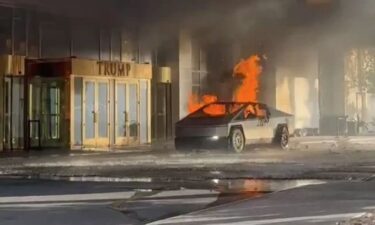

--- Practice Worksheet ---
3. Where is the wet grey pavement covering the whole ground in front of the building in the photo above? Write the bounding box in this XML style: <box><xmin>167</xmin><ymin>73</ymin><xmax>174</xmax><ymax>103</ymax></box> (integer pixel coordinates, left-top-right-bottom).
<box><xmin>0</xmin><ymin>138</ymin><xmax>375</xmax><ymax>225</ymax></box>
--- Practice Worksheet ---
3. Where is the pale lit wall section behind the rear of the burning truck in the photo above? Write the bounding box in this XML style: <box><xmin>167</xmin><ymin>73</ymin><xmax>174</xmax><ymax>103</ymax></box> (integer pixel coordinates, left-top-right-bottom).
<box><xmin>276</xmin><ymin>40</ymin><xmax>319</xmax><ymax>132</ymax></box>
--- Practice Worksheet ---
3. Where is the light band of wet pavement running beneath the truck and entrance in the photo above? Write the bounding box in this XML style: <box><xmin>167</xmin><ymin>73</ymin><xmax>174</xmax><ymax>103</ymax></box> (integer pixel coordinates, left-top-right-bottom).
<box><xmin>0</xmin><ymin>137</ymin><xmax>375</xmax><ymax>181</ymax></box>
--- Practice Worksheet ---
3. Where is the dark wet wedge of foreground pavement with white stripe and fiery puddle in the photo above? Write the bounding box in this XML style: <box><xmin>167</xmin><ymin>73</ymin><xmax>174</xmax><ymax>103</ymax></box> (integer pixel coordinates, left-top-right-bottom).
<box><xmin>0</xmin><ymin>177</ymin><xmax>321</xmax><ymax>224</ymax></box>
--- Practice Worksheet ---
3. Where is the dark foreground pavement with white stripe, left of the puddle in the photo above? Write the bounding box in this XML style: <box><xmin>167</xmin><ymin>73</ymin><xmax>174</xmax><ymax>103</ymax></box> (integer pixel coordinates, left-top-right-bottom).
<box><xmin>0</xmin><ymin>179</ymin><xmax>137</xmax><ymax>225</ymax></box>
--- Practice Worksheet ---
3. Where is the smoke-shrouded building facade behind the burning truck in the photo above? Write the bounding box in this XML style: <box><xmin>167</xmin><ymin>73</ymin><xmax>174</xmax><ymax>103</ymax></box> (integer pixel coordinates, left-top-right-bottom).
<box><xmin>0</xmin><ymin>0</ymin><xmax>374</xmax><ymax>153</ymax></box>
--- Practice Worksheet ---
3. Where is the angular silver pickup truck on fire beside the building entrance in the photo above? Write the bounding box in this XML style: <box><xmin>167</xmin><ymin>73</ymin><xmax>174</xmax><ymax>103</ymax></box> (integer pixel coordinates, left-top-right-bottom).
<box><xmin>175</xmin><ymin>102</ymin><xmax>293</xmax><ymax>153</ymax></box>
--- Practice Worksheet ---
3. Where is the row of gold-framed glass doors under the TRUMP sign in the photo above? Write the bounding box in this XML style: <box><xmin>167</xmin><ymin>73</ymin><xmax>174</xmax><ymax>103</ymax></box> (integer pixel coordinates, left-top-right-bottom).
<box><xmin>78</xmin><ymin>78</ymin><xmax>149</xmax><ymax>148</ymax></box>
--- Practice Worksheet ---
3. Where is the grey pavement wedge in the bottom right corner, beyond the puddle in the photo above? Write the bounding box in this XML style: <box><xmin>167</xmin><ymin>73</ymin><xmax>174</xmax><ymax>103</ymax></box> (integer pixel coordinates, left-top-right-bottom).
<box><xmin>150</xmin><ymin>181</ymin><xmax>375</xmax><ymax>225</ymax></box>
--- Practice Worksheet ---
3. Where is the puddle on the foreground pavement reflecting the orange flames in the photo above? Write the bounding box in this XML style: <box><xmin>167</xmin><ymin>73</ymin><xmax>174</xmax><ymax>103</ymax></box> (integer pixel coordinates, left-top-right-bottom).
<box><xmin>112</xmin><ymin>179</ymin><xmax>324</xmax><ymax>223</ymax></box>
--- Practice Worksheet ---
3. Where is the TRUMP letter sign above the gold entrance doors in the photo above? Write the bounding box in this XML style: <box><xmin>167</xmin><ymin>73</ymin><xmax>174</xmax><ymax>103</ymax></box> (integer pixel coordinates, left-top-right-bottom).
<box><xmin>97</xmin><ymin>61</ymin><xmax>131</xmax><ymax>77</ymax></box>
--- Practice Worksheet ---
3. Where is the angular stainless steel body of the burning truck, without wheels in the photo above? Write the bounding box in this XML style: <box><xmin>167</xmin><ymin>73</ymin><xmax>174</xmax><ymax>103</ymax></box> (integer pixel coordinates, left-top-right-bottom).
<box><xmin>175</xmin><ymin>102</ymin><xmax>294</xmax><ymax>147</ymax></box>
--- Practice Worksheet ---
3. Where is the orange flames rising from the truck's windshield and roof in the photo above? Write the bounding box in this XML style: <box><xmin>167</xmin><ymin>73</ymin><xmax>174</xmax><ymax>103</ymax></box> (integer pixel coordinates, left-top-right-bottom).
<box><xmin>188</xmin><ymin>55</ymin><xmax>262</xmax><ymax>116</ymax></box>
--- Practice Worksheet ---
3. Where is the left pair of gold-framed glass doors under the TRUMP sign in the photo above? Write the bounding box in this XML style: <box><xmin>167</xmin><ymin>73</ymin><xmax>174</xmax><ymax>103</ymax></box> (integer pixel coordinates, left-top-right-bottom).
<box><xmin>83</xmin><ymin>80</ymin><xmax>109</xmax><ymax>147</ymax></box>
